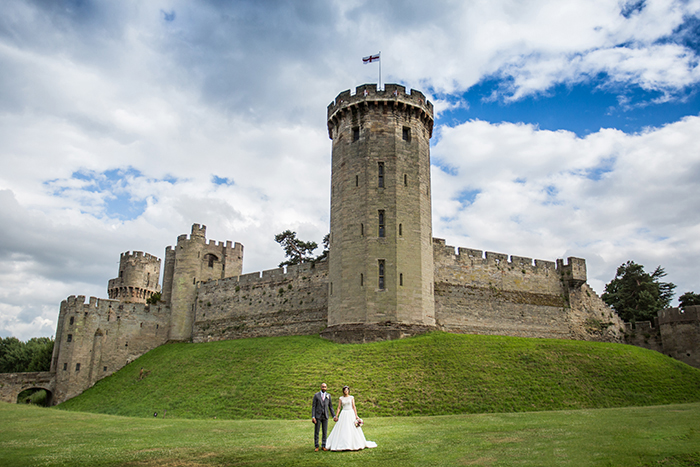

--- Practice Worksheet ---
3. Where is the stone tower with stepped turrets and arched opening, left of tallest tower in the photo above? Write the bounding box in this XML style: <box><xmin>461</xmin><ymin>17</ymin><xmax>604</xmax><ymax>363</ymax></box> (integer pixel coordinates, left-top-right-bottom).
<box><xmin>163</xmin><ymin>224</ymin><xmax>243</xmax><ymax>341</ymax></box>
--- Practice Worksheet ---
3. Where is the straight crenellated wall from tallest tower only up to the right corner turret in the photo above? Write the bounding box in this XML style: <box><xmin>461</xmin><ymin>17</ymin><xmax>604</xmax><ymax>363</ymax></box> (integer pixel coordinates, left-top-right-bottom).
<box><xmin>433</xmin><ymin>239</ymin><xmax>569</xmax><ymax>339</ymax></box>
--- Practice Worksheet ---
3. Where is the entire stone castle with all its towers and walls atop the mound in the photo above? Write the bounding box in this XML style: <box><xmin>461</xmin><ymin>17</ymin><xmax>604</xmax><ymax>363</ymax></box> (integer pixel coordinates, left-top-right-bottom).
<box><xmin>0</xmin><ymin>84</ymin><xmax>700</xmax><ymax>404</ymax></box>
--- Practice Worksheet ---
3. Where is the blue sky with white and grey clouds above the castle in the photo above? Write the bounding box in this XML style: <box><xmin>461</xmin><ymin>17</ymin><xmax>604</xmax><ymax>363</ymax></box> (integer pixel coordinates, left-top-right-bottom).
<box><xmin>0</xmin><ymin>0</ymin><xmax>700</xmax><ymax>340</ymax></box>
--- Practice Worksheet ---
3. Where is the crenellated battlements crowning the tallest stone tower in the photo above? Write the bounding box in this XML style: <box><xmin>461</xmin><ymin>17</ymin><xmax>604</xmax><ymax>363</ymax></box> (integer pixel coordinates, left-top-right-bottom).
<box><xmin>328</xmin><ymin>84</ymin><xmax>433</xmax><ymax>139</ymax></box>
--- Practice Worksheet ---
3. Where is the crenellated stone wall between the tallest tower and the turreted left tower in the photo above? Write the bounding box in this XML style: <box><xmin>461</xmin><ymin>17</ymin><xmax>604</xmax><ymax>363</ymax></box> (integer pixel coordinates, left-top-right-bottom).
<box><xmin>192</xmin><ymin>261</ymin><xmax>328</xmax><ymax>342</ymax></box>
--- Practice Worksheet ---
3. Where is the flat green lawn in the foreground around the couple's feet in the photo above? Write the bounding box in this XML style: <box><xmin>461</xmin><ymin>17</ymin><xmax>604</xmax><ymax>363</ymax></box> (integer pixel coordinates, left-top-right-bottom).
<box><xmin>0</xmin><ymin>403</ymin><xmax>700</xmax><ymax>467</ymax></box>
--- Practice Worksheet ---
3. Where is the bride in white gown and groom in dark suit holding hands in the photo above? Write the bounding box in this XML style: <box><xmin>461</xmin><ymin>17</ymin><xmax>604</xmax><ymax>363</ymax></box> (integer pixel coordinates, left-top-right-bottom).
<box><xmin>311</xmin><ymin>383</ymin><xmax>377</xmax><ymax>451</ymax></box>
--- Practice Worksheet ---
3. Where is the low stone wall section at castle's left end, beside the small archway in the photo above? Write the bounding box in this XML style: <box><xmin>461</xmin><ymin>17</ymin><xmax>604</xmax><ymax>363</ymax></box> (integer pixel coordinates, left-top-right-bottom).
<box><xmin>51</xmin><ymin>295</ymin><xmax>170</xmax><ymax>404</ymax></box>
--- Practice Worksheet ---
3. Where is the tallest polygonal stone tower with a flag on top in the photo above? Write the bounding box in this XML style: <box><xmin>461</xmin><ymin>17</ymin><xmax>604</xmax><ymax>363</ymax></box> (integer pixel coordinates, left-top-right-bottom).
<box><xmin>322</xmin><ymin>84</ymin><xmax>435</xmax><ymax>342</ymax></box>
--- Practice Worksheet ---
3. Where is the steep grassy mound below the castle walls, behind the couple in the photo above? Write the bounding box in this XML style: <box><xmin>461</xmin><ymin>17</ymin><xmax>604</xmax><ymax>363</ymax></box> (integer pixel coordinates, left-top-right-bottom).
<box><xmin>58</xmin><ymin>332</ymin><xmax>700</xmax><ymax>419</ymax></box>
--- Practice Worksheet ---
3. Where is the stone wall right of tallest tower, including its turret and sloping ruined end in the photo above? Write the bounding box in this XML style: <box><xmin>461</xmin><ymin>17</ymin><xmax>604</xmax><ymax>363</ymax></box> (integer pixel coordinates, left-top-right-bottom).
<box><xmin>433</xmin><ymin>238</ymin><xmax>623</xmax><ymax>342</ymax></box>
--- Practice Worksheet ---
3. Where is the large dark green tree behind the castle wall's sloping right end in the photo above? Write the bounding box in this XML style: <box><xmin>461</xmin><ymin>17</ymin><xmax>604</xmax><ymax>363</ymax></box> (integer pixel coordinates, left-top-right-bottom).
<box><xmin>601</xmin><ymin>261</ymin><xmax>676</xmax><ymax>321</ymax></box>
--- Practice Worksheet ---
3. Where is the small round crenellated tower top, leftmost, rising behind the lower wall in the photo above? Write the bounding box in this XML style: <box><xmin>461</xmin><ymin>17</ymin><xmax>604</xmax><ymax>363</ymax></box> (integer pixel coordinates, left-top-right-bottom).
<box><xmin>107</xmin><ymin>251</ymin><xmax>160</xmax><ymax>303</ymax></box>
